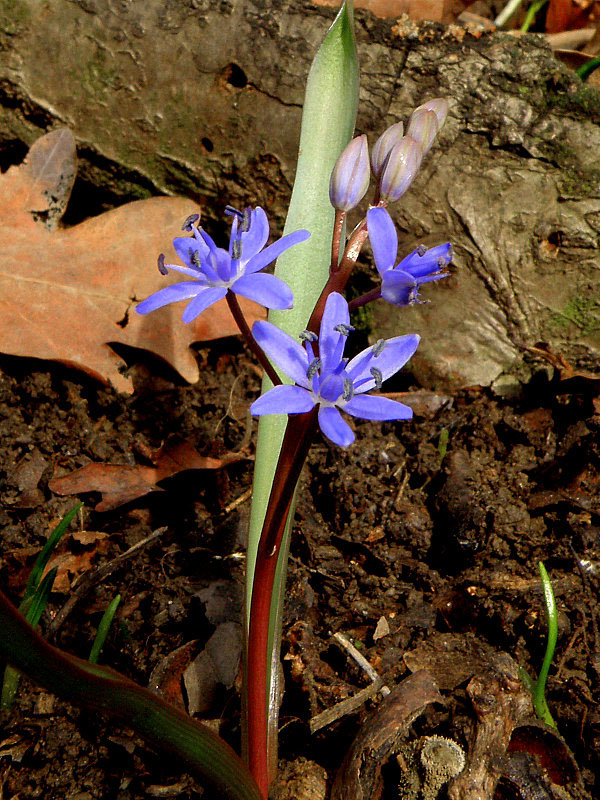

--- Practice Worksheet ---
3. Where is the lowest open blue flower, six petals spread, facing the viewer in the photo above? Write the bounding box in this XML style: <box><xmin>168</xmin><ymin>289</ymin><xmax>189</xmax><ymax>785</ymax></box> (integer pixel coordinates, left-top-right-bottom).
<box><xmin>250</xmin><ymin>292</ymin><xmax>419</xmax><ymax>447</ymax></box>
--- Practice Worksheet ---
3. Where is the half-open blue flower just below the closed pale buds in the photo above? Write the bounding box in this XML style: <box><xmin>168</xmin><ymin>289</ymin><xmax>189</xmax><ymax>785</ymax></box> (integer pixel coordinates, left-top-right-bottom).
<box><xmin>367</xmin><ymin>208</ymin><xmax>452</xmax><ymax>306</ymax></box>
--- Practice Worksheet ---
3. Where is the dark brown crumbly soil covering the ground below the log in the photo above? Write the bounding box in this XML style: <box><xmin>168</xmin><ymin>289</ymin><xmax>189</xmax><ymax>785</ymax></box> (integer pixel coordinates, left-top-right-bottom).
<box><xmin>0</xmin><ymin>339</ymin><xmax>600</xmax><ymax>800</ymax></box>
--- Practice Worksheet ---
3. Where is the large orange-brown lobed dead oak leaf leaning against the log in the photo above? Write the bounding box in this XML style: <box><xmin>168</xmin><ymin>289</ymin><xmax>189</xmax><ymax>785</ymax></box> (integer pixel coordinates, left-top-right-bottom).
<box><xmin>0</xmin><ymin>128</ymin><xmax>264</xmax><ymax>392</ymax></box>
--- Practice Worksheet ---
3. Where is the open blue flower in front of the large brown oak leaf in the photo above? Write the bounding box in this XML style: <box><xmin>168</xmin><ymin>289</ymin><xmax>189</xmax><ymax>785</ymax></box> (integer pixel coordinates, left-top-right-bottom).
<box><xmin>136</xmin><ymin>207</ymin><xmax>310</xmax><ymax>322</ymax></box>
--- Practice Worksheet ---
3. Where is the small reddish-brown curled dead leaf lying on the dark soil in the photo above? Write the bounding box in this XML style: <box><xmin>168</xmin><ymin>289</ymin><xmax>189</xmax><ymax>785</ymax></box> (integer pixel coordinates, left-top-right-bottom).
<box><xmin>48</xmin><ymin>436</ymin><xmax>246</xmax><ymax>511</ymax></box>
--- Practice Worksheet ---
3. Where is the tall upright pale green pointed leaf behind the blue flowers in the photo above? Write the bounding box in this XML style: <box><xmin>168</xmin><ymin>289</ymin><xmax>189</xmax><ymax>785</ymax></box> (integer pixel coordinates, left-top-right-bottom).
<box><xmin>247</xmin><ymin>2</ymin><xmax>358</xmax><ymax>610</ymax></box>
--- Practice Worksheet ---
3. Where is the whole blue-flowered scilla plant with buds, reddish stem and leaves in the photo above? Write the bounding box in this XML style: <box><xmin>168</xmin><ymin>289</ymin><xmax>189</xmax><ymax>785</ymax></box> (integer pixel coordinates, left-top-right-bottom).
<box><xmin>0</xmin><ymin>2</ymin><xmax>452</xmax><ymax>800</ymax></box>
